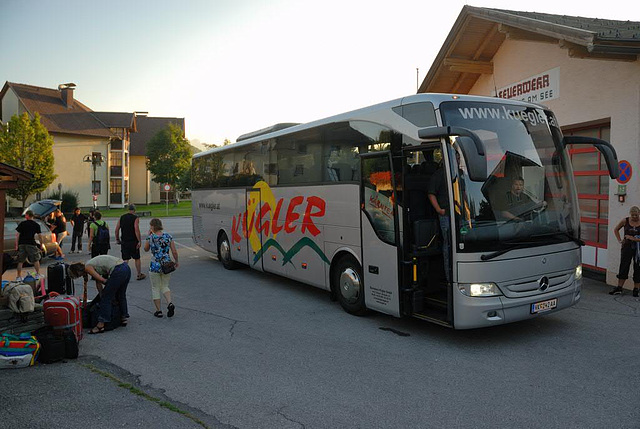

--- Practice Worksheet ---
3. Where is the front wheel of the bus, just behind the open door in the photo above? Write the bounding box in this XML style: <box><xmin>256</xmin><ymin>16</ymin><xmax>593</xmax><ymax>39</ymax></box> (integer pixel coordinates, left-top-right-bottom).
<box><xmin>333</xmin><ymin>255</ymin><xmax>367</xmax><ymax>316</ymax></box>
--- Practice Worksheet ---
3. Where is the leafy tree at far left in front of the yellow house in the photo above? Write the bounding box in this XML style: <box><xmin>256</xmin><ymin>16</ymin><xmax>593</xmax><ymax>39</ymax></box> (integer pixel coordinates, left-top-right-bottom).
<box><xmin>0</xmin><ymin>112</ymin><xmax>58</xmax><ymax>209</ymax></box>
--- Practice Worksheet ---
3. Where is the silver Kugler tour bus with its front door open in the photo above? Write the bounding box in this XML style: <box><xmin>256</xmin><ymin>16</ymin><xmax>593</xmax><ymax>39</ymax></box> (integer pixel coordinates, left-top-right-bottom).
<box><xmin>192</xmin><ymin>94</ymin><xmax>618</xmax><ymax>329</ymax></box>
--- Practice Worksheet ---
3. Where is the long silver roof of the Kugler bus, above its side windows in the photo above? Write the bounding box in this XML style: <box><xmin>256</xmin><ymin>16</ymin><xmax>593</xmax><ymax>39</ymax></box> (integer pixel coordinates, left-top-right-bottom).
<box><xmin>193</xmin><ymin>93</ymin><xmax>546</xmax><ymax>158</ymax></box>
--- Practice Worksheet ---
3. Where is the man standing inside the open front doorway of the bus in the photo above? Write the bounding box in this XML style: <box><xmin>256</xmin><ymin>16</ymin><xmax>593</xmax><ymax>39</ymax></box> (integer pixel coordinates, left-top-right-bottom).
<box><xmin>427</xmin><ymin>162</ymin><xmax>451</xmax><ymax>283</ymax></box>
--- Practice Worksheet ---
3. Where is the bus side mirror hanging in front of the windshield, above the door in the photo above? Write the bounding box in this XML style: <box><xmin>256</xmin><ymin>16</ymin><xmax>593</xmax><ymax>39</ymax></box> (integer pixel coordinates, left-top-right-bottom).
<box><xmin>418</xmin><ymin>127</ymin><xmax>487</xmax><ymax>182</ymax></box>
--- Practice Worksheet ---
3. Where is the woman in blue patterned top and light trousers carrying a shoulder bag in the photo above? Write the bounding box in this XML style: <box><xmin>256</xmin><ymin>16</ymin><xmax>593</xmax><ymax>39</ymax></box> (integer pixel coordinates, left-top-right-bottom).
<box><xmin>144</xmin><ymin>218</ymin><xmax>178</xmax><ymax>317</ymax></box>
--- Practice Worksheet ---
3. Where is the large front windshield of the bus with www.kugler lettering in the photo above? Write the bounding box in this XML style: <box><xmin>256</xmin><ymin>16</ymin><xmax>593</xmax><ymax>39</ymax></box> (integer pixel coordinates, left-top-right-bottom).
<box><xmin>441</xmin><ymin>102</ymin><xmax>579</xmax><ymax>252</ymax></box>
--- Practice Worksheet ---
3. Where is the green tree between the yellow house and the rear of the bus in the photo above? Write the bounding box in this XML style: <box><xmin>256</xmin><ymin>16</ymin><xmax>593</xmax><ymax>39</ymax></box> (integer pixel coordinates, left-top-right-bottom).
<box><xmin>147</xmin><ymin>124</ymin><xmax>191</xmax><ymax>188</ymax></box>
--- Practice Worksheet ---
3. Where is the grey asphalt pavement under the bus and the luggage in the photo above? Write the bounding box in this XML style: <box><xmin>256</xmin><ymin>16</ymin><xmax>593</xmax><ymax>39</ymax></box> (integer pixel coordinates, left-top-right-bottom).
<box><xmin>0</xmin><ymin>219</ymin><xmax>640</xmax><ymax>428</ymax></box>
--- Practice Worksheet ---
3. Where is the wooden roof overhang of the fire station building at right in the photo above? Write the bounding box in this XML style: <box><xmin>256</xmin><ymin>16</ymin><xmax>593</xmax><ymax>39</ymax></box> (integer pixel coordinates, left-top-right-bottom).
<box><xmin>418</xmin><ymin>6</ymin><xmax>640</xmax><ymax>94</ymax></box>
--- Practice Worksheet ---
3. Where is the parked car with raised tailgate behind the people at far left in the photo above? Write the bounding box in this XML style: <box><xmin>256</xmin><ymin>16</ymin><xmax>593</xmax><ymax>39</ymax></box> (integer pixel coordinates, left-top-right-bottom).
<box><xmin>4</xmin><ymin>200</ymin><xmax>61</xmax><ymax>263</ymax></box>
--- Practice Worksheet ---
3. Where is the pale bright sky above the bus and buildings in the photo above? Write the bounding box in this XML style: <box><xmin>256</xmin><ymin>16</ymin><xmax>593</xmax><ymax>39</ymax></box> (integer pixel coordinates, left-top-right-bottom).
<box><xmin>0</xmin><ymin>0</ymin><xmax>640</xmax><ymax>147</ymax></box>
